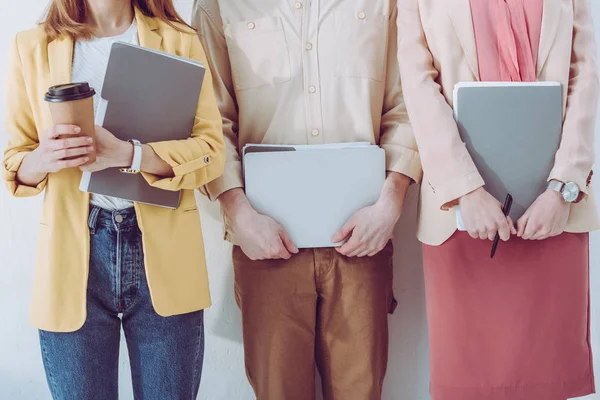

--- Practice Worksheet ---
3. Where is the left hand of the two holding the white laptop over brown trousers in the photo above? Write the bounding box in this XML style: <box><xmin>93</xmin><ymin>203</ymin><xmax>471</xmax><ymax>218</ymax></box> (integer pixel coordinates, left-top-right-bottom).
<box><xmin>219</xmin><ymin>188</ymin><xmax>298</xmax><ymax>260</ymax></box>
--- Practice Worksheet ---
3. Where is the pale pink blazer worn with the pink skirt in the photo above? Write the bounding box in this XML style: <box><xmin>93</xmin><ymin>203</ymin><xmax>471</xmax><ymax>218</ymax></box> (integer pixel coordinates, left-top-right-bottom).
<box><xmin>398</xmin><ymin>0</ymin><xmax>600</xmax><ymax>245</ymax></box>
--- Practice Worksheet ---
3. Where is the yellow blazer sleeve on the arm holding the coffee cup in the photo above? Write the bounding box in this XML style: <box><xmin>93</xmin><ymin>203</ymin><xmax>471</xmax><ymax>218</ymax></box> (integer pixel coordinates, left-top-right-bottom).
<box><xmin>2</xmin><ymin>35</ymin><xmax>48</xmax><ymax>197</ymax></box>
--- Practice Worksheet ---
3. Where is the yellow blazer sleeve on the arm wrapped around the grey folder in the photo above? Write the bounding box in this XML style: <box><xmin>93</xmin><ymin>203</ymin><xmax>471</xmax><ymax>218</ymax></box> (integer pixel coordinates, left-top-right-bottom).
<box><xmin>142</xmin><ymin>34</ymin><xmax>225</xmax><ymax>191</ymax></box>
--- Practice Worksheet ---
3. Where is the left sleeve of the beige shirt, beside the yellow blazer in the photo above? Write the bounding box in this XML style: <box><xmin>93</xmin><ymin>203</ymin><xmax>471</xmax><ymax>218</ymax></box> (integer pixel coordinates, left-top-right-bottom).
<box><xmin>192</xmin><ymin>0</ymin><xmax>244</xmax><ymax>201</ymax></box>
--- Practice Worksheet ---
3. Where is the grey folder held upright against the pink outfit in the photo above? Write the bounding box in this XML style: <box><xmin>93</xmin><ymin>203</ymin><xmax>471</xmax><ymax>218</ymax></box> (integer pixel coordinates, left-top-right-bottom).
<box><xmin>454</xmin><ymin>82</ymin><xmax>563</xmax><ymax>221</ymax></box>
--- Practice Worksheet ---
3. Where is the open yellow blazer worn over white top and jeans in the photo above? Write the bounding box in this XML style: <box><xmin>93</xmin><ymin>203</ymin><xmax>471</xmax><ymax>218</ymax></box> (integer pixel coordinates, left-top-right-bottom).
<box><xmin>2</xmin><ymin>10</ymin><xmax>225</xmax><ymax>332</ymax></box>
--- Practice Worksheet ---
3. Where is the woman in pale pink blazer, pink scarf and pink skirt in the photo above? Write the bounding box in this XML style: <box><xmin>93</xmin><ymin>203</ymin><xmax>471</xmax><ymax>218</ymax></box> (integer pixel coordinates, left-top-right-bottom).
<box><xmin>398</xmin><ymin>0</ymin><xmax>599</xmax><ymax>400</ymax></box>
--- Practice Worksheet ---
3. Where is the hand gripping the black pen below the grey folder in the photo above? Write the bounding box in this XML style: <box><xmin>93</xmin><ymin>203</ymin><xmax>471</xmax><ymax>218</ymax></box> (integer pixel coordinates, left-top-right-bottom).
<box><xmin>459</xmin><ymin>187</ymin><xmax>517</xmax><ymax>241</ymax></box>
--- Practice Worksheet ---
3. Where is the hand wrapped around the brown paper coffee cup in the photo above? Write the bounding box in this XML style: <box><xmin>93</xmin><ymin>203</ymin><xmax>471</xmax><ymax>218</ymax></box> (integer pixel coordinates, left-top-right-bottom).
<box><xmin>30</xmin><ymin>125</ymin><xmax>94</xmax><ymax>175</ymax></box>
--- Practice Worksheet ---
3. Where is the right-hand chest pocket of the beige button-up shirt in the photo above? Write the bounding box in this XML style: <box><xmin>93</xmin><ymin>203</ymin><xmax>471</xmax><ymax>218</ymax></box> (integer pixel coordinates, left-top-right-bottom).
<box><xmin>334</xmin><ymin>10</ymin><xmax>390</xmax><ymax>82</ymax></box>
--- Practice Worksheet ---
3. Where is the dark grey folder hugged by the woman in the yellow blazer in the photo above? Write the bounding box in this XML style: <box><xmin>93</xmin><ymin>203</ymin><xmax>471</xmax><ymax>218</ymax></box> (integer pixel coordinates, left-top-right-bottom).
<box><xmin>79</xmin><ymin>42</ymin><xmax>205</xmax><ymax>209</ymax></box>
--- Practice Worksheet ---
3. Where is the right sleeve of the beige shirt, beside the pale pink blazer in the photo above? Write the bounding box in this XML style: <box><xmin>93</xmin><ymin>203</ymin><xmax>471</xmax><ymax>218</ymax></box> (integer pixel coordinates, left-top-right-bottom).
<box><xmin>380</xmin><ymin>2</ymin><xmax>423</xmax><ymax>182</ymax></box>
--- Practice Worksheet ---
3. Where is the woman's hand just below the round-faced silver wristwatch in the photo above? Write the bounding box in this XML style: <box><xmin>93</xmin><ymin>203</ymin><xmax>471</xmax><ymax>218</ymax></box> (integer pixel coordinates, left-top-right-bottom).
<box><xmin>517</xmin><ymin>189</ymin><xmax>571</xmax><ymax>240</ymax></box>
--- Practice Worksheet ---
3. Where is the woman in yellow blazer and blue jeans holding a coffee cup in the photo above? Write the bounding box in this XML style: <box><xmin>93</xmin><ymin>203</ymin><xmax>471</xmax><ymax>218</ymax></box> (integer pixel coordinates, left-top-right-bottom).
<box><xmin>2</xmin><ymin>0</ymin><xmax>225</xmax><ymax>399</ymax></box>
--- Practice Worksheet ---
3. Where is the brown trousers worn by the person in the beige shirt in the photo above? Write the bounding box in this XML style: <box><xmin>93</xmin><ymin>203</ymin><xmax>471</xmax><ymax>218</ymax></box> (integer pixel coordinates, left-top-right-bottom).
<box><xmin>233</xmin><ymin>243</ymin><xmax>396</xmax><ymax>400</ymax></box>
